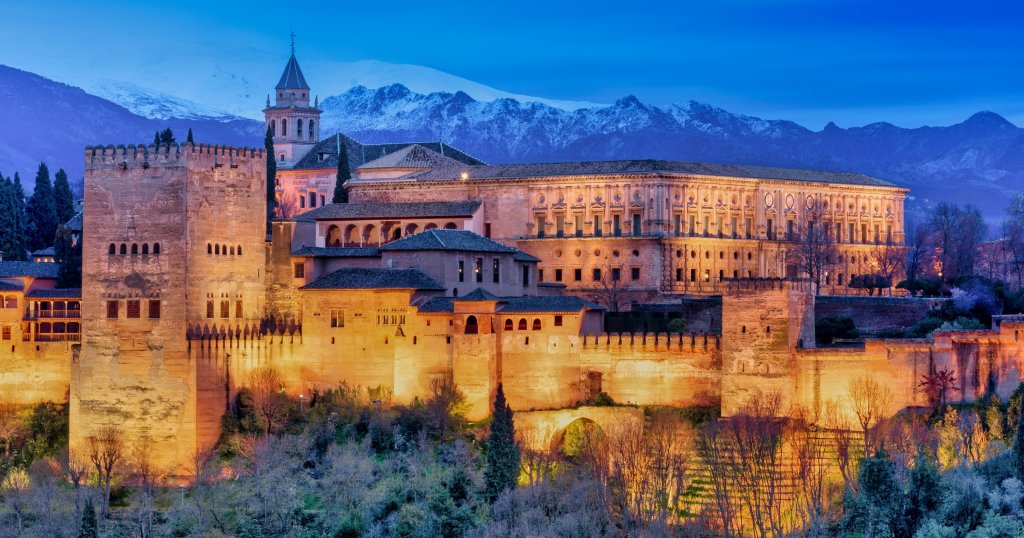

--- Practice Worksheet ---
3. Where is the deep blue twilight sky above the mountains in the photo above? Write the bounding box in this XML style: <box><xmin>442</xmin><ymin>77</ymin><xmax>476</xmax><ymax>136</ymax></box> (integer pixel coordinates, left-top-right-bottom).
<box><xmin>0</xmin><ymin>0</ymin><xmax>1024</xmax><ymax>129</ymax></box>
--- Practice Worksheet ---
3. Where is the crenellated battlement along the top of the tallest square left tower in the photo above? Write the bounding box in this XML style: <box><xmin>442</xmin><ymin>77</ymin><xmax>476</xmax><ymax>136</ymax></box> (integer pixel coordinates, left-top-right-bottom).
<box><xmin>85</xmin><ymin>143</ymin><xmax>264</xmax><ymax>170</ymax></box>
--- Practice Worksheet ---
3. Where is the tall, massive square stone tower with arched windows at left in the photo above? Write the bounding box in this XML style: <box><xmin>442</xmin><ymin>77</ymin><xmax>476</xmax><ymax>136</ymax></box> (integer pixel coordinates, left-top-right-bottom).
<box><xmin>70</xmin><ymin>144</ymin><xmax>266</xmax><ymax>473</ymax></box>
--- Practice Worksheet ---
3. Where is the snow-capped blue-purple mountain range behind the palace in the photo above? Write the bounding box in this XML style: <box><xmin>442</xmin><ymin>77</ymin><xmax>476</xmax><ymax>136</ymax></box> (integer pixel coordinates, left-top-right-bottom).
<box><xmin>0</xmin><ymin>67</ymin><xmax>1024</xmax><ymax>219</ymax></box>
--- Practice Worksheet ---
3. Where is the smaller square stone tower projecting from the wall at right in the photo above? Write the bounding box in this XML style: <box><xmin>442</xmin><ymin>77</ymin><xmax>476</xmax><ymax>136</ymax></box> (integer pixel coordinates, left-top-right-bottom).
<box><xmin>722</xmin><ymin>279</ymin><xmax>815</xmax><ymax>416</ymax></box>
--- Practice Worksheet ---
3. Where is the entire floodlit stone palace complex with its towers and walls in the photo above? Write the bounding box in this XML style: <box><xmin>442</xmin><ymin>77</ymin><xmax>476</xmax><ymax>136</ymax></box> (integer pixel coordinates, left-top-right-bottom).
<box><xmin>0</xmin><ymin>47</ymin><xmax>1024</xmax><ymax>467</ymax></box>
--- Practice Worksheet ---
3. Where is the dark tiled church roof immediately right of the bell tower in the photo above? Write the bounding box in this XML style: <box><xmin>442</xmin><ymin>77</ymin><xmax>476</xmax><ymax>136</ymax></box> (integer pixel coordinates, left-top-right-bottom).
<box><xmin>294</xmin><ymin>132</ymin><xmax>484</xmax><ymax>170</ymax></box>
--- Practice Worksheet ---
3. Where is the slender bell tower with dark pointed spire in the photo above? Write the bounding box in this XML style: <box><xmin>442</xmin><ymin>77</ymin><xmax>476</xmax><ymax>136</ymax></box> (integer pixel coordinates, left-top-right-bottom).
<box><xmin>263</xmin><ymin>33</ymin><xmax>321</xmax><ymax>168</ymax></box>
